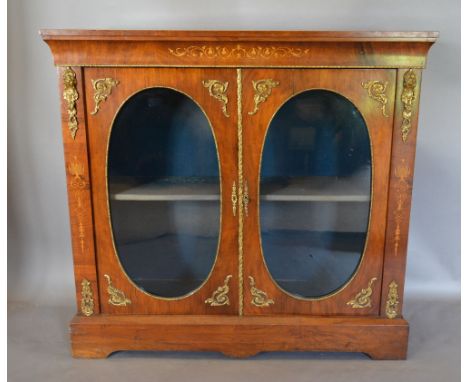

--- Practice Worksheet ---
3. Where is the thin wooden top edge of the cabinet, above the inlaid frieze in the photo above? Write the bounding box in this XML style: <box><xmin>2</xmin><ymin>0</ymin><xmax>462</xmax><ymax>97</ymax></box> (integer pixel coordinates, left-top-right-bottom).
<box><xmin>40</xmin><ymin>29</ymin><xmax>439</xmax><ymax>42</ymax></box>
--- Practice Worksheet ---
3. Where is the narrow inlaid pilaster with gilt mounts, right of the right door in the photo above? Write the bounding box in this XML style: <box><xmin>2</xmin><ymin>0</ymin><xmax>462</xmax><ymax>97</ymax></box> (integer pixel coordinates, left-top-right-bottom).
<box><xmin>380</xmin><ymin>69</ymin><xmax>422</xmax><ymax>318</ymax></box>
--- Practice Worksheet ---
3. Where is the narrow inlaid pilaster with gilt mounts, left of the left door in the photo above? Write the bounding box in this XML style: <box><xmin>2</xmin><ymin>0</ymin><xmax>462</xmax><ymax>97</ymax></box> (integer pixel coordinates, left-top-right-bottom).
<box><xmin>58</xmin><ymin>67</ymin><xmax>100</xmax><ymax>316</ymax></box>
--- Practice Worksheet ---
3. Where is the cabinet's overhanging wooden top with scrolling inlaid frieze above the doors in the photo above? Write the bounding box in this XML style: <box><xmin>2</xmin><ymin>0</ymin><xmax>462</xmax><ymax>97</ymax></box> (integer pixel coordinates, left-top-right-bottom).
<box><xmin>40</xmin><ymin>29</ymin><xmax>438</xmax><ymax>68</ymax></box>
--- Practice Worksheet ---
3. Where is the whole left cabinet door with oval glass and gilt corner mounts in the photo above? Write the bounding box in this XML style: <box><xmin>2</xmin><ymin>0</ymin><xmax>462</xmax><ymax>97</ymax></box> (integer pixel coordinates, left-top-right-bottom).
<box><xmin>85</xmin><ymin>68</ymin><xmax>238</xmax><ymax>314</ymax></box>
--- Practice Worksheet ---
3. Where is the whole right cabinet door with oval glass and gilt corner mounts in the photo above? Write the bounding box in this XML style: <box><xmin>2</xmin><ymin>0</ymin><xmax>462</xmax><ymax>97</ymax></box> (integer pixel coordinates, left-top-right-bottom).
<box><xmin>242</xmin><ymin>69</ymin><xmax>395</xmax><ymax>315</ymax></box>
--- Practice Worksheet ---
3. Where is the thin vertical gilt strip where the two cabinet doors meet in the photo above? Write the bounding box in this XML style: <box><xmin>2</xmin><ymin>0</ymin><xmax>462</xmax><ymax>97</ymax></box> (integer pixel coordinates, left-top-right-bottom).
<box><xmin>237</xmin><ymin>68</ymin><xmax>244</xmax><ymax>316</ymax></box>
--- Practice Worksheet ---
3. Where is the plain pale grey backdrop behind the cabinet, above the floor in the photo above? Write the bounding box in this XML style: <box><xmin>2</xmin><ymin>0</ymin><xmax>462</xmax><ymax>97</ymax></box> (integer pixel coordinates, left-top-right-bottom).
<box><xmin>8</xmin><ymin>0</ymin><xmax>460</xmax><ymax>305</ymax></box>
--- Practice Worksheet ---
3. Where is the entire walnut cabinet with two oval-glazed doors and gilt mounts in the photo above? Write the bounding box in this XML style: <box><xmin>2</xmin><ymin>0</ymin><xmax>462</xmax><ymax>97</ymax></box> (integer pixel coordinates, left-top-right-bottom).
<box><xmin>41</xmin><ymin>30</ymin><xmax>437</xmax><ymax>359</ymax></box>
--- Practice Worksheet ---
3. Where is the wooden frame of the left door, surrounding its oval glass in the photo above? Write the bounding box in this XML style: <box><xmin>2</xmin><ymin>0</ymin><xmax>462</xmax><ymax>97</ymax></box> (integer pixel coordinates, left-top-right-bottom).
<box><xmin>84</xmin><ymin>67</ymin><xmax>238</xmax><ymax>314</ymax></box>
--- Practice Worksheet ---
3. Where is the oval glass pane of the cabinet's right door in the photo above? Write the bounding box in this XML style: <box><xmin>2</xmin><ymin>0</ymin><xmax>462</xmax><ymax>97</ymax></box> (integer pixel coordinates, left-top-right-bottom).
<box><xmin>260</xmin><ymin>90</ymin><xmax>371</xmax><ymax>298</ymax></box>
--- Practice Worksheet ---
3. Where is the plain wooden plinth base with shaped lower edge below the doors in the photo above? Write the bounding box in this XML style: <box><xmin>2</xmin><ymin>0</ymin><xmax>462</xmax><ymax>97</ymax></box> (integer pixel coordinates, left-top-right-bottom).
<box><xmin>71</xmin><ymin>315</ymin><xmax>408</xmax><ymax>359</ymax></box>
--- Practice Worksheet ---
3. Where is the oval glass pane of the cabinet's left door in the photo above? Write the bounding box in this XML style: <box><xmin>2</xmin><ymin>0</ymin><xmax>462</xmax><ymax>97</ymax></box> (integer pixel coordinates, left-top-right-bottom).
<box><xmin>108</xmin><ymin>88</ymin><xmax>220</xmax><ymax>298</ymax></box>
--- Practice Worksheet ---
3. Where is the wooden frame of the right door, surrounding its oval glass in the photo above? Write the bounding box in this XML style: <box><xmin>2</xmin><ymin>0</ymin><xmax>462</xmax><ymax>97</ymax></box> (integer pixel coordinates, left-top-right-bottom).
<box><xmin>242</xmin><ymin>69</ymin><xmax>396</xmax><ymax>315</ymax></box>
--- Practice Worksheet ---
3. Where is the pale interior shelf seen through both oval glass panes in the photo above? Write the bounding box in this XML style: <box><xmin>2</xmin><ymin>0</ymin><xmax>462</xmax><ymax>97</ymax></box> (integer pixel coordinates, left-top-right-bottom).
<box><xmin>111</xmin><ymin>176</ymin><xmax>370</xmax><ymax>202</ymax></box>
